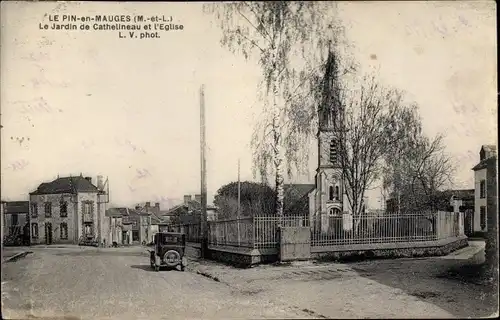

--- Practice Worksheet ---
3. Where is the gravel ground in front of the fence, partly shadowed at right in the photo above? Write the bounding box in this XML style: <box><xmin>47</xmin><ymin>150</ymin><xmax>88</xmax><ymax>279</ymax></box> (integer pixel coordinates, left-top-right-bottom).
<box><xmin>188</xmin><ymin>254</ymin><xmax>498</xmax><ymax>318</ymax></box>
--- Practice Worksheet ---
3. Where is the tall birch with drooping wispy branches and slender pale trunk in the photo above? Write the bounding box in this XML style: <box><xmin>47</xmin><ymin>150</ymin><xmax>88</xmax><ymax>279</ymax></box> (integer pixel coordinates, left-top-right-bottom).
<box><xmin>205</xmin><ymin>1</ymin><xmax>348</xmax><ymax>221</ymax></box>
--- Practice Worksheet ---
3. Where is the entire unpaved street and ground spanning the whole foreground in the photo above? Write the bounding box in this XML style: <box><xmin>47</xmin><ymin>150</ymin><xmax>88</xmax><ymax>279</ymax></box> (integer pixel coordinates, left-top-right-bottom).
<box><xmin>2</xmin><ymin>242</ymin><xmax>494</xmax><ymax>319</ymax></box>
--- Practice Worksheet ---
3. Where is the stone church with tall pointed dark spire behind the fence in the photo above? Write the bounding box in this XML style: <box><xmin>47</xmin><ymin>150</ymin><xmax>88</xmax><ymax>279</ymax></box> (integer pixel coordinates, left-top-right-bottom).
<box><xmin>285</xmin><ymin>48</ymin><xmax>352</xmax><ymax>232</ymax></box>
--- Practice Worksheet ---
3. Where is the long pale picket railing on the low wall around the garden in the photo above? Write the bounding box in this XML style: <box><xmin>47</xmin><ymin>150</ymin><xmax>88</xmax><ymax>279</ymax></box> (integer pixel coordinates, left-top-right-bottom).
<box><xmin>171</xmin><ymin>212</ymin><xmax>460</xmax><ymax>249</ymax></box>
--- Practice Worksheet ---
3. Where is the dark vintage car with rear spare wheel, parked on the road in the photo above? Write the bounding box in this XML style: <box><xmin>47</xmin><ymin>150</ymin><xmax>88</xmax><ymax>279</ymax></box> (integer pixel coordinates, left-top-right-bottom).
<box><xmin>149</xmin><ymin>232</ymin><xmax>187</xmax><ymax>271</ymax></box>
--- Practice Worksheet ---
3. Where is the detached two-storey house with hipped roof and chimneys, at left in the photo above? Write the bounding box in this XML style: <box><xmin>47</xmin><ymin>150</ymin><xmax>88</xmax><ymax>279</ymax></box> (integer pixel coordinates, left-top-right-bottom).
<box><xmin>29</xmin><ymin>174</ymin><xmax>109</xmax><ymax>245</ymax></box>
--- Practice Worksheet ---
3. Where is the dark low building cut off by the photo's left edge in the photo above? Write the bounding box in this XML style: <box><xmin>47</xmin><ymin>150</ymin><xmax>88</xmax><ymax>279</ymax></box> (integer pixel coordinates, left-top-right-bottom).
<box><xmin>1</xmin><ymin>201</ymin><xmax>30</xmax><ymax>245</ymax></box>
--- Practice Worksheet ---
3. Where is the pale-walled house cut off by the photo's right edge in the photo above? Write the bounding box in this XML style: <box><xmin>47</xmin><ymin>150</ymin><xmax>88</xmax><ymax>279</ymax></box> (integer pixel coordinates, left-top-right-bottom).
<box><xmin>472</xmin><ymin>145</ymin><xmax>497</xmax><ymax>234</ymax></box>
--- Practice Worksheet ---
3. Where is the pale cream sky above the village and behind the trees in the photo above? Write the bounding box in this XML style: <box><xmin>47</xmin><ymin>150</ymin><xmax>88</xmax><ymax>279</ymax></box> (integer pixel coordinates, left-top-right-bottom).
<box><xmin>0</xmin><ymin>1</ymin><xmax>497</xmax><ymax>207</ymax></box>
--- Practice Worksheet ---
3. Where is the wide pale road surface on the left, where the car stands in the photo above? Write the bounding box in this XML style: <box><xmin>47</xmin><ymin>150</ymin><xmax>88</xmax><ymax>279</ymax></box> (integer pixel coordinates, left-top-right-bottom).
<box><xmin>2</xmin><ymin>248</ymin><xmax>313</xmax><ymax>319</ymax></box>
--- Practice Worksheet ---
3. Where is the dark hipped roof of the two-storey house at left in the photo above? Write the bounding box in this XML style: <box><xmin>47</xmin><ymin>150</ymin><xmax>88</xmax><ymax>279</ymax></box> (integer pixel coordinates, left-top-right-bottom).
<box><xmin>30</xmin><ymin>176</ymin><xmax>99</xmax><ymax>195</ymax></box>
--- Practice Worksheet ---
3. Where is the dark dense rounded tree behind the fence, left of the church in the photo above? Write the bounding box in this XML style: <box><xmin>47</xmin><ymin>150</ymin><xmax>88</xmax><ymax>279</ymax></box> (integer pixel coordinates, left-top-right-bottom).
<box><xmin>214</xmin><ymin>181</ymin><xmax>276</xmax><ymax>219</ymax></box>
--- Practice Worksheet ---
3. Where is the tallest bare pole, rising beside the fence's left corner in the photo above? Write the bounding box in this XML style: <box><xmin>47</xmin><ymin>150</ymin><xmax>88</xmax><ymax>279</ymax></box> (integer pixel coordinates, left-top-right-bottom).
<box><xmin>200</xmin><ymin>85</ymin><xmax>208</xmax><ymax>258</ymax></box>
